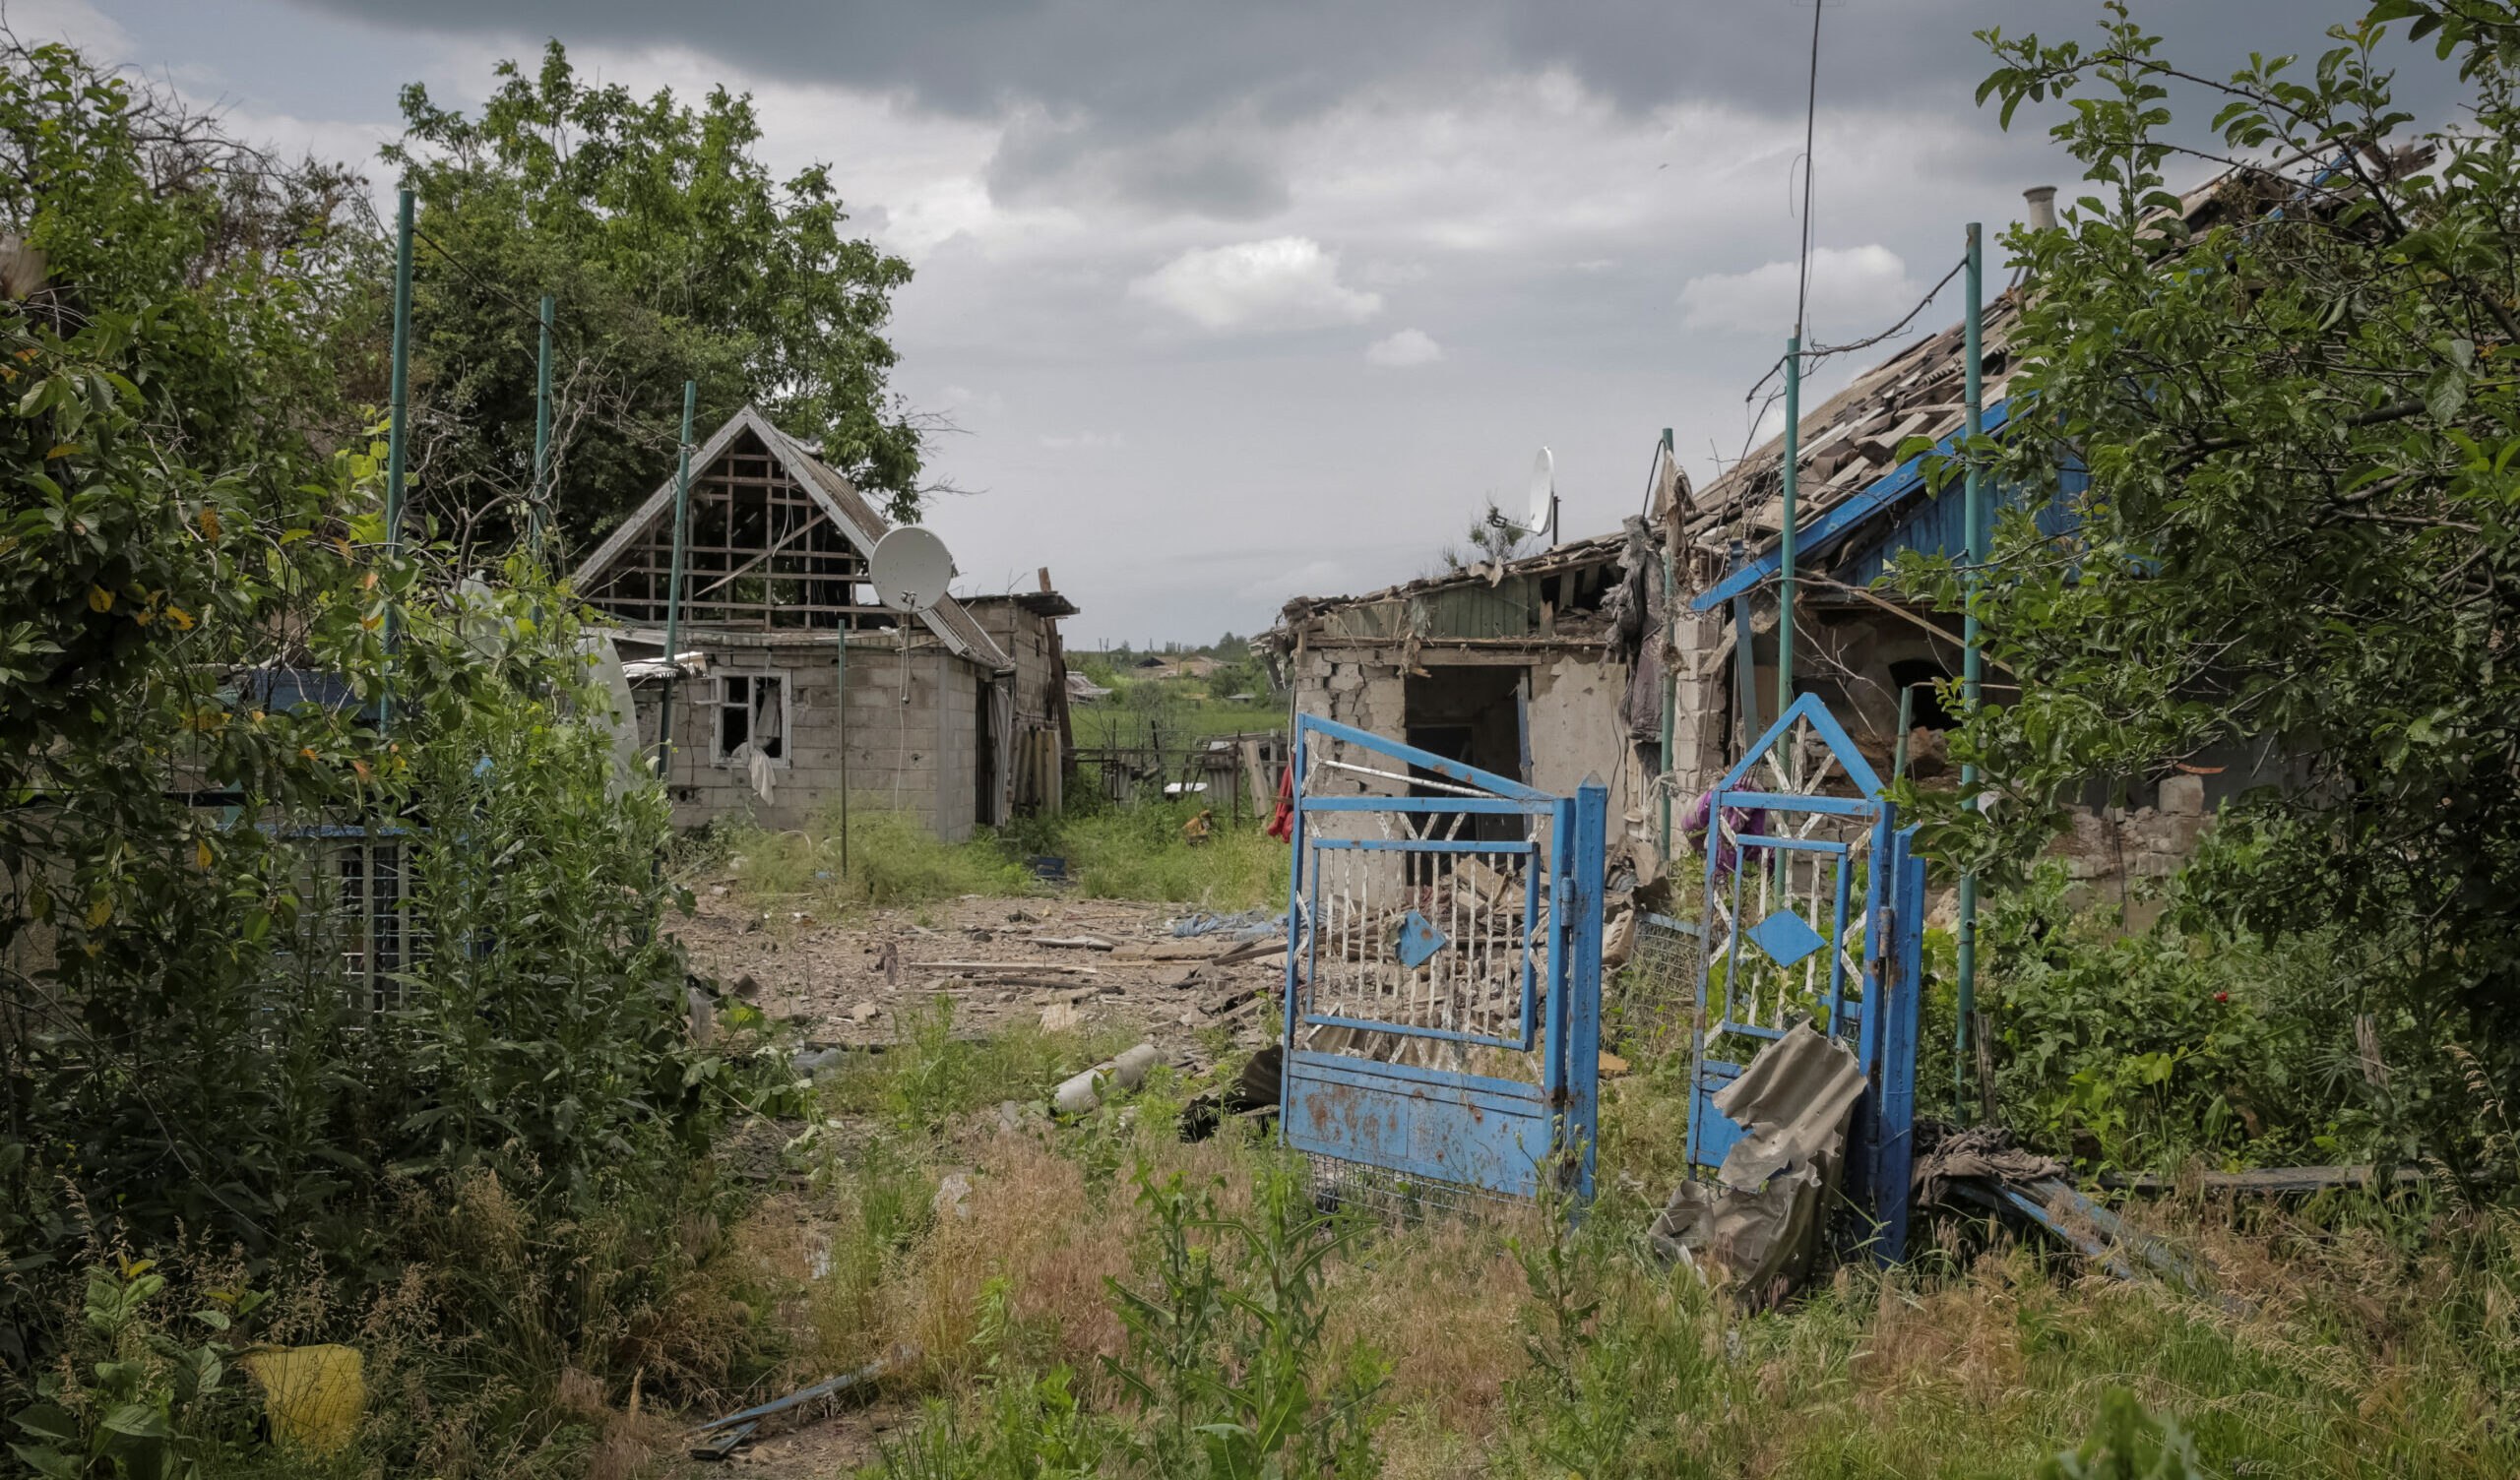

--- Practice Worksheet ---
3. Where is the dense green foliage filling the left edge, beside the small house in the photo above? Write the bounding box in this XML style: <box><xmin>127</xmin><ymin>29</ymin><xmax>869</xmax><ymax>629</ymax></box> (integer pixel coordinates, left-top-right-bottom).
<box><xmin>0</xmin><ymin>48</ymin><xmax>738</xmax><ymax>1387</ymax></box>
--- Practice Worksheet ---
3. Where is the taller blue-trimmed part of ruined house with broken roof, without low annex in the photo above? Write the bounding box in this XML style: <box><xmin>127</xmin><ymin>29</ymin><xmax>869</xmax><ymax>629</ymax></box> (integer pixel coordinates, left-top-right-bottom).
<box><xmin>1648</xmin><ymin>154</ymin><xmax>2368</xmax><ymax>903</ymax></box>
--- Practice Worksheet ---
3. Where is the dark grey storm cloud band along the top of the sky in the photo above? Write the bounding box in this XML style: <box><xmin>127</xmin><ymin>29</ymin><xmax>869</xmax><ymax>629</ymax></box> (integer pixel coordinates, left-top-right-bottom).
<box><xmin>285</xmin><ymin>0</ymin><xmax>2428</xmax><ymax>221</ymax></box>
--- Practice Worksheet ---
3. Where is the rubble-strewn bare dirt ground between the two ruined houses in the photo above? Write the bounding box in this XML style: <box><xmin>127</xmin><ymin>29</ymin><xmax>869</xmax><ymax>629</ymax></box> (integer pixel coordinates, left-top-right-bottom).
<box><xmin>667</xmin><ymin>884</ymin><xmax>1286</xmax><ymax>1060</ymax></box>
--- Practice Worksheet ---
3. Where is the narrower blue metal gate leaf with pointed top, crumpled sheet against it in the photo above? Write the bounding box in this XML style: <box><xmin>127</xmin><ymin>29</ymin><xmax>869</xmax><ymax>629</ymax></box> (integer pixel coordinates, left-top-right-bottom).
<box><xmin>1688</xmin><ymin>695</ymin><xmax>1925</xmax><ymax>1264</ymax></box>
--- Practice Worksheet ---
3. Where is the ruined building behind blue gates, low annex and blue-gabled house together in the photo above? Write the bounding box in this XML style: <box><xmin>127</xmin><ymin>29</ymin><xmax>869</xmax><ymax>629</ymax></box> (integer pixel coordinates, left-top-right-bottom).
<box><xmin>1255</xmin><ymin>158</ymin><xmax>2348</xmax><ymax>903</ymax></box>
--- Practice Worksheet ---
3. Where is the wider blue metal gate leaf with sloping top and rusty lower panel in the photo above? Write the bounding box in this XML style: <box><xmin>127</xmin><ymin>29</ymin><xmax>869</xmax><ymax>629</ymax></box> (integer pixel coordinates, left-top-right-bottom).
<box><xmin>1280</xmin><ymin>714</ymin><xmax>1607</xmax><ymax>1201</ymax></box>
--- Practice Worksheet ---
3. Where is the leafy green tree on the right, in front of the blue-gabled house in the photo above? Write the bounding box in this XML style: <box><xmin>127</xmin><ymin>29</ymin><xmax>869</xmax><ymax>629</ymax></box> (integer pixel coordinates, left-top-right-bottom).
<box><xmin>1903</xmin><ymin>0</ymin><xmax>2520</xmax><ymax>1160</ymax></box>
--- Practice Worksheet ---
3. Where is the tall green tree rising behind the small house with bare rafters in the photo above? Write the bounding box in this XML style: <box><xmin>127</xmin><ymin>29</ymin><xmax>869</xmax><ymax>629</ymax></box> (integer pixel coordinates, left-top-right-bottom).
<box><xmin>386</xmin><ymin>40</ymin><xmax>922</xmax><ymax>563</ymax></box>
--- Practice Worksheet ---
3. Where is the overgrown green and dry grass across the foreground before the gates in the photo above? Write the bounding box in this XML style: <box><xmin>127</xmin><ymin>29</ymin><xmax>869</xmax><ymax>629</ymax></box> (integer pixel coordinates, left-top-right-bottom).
<box><xmin>63</xmin><ymin>976</ymin><xmax>2520</xmax><ymax>1480</ymax></box>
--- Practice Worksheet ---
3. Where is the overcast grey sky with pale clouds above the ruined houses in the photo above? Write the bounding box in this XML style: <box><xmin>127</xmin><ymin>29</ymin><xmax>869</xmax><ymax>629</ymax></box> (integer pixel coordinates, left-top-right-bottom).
<box><xmin>8</xmin><ymin>0</ymin><xmax>2439</xmax><ymax>645</ymax></box>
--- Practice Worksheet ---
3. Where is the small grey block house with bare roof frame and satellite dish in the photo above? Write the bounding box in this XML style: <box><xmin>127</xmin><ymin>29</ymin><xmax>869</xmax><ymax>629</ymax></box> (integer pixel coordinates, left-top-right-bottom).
<box><xmin>572</xmin><ymin>407</ymin><xmax>1076</xmax><ymax>840</ymax></box>
